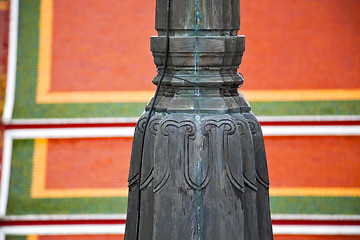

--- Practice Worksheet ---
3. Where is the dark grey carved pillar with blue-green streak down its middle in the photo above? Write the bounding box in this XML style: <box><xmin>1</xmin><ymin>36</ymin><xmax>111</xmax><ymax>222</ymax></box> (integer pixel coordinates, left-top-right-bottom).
<box><xmin>125</xmin><ymin>0</ymin><xmax>273</xmax><ymax>240</ymax></box>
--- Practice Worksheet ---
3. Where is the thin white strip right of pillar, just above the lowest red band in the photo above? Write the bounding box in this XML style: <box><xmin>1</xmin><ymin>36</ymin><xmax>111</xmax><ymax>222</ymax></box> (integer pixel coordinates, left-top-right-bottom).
<box><xmin>271</xmin><ymin>214</ymin><xmax>360</xmax><ymax>221</ymax></box>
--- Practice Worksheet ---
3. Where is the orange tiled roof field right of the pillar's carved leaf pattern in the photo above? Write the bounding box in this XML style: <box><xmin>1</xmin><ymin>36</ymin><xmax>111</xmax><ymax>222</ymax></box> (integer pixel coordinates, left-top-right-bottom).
<box><xmin>265</xmin><ymin>136</ymin><xmax>360</xmax><ymax>188</ymax></box>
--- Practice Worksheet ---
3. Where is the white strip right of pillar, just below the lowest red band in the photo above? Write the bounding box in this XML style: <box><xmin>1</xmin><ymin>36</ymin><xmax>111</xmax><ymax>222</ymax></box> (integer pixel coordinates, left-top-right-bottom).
<box><xmin>273</xmin><ymin>225</ymin><xmax>360</xmax><ymax>235</ymax></box>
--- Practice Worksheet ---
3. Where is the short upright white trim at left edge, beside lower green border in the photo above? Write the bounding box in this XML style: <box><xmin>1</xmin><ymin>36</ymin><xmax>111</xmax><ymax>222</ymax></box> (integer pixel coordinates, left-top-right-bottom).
<box><xmin>0</xmin><ymin>131</ymin><xmax>13</xmax><ymax>217</ymax></box>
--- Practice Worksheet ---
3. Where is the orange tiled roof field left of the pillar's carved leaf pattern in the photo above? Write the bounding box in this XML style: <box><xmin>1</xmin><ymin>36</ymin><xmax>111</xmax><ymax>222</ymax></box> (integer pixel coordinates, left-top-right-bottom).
<box><xmin>46</xmin><ymin>138</ymin><xmax>132</xmax><ymax>189</ymax></box>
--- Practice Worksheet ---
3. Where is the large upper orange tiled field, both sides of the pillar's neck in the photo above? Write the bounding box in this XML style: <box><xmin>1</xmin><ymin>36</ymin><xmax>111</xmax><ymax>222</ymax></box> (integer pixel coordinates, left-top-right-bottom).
<box><xmin>51</xmin><ymin>0</ymin><xmax>360</xmax><ymax>91</ymax></box>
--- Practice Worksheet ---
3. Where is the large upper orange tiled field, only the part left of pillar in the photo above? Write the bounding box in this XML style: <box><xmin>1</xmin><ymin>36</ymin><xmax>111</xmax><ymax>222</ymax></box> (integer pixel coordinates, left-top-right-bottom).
<box><xmin>51</xmin><ymin>0</ymin><xmax>156</xmax><ymax>91</ymax></box>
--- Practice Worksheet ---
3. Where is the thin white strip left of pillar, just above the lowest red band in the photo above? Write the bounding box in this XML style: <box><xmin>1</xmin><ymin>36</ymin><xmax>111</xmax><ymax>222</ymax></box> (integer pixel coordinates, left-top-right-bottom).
<box><xmin>2</xmin><ymin>214</ymin><xmax>126</xmax><ymax>221</ymax></box>
